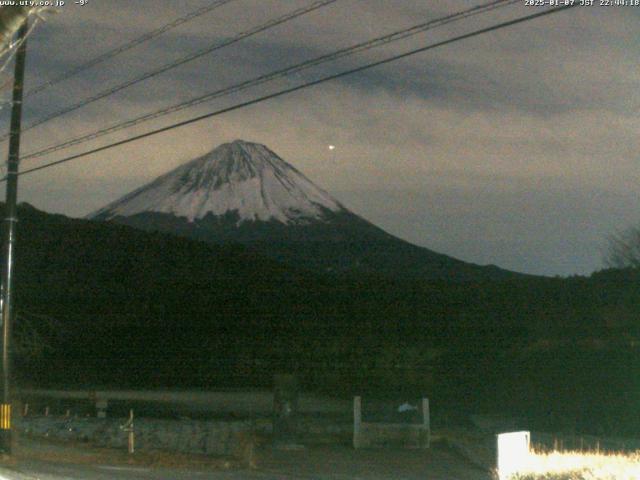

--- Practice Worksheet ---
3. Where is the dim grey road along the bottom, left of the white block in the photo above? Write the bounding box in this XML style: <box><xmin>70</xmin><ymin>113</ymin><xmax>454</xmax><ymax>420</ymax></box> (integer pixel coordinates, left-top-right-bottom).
<box><xmin>0</xmin><ymin>447</ymin><xmax>491</xmax><ymax>480</ymax></box>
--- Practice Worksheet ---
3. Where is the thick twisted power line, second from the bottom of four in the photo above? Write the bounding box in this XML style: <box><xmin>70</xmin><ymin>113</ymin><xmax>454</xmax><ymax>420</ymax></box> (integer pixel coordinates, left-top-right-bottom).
<box><xmin>22</xmin><ymin>0</ymin><xmax>520</xmax><ymax>160</ymax></box>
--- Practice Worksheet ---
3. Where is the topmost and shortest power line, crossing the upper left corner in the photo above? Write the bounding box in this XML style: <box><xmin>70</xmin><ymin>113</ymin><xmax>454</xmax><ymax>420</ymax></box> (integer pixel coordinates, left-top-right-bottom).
<box><xmin>8</xmin><ymin>0</ymin><xmax>235</xmax><ymax>102</ymax></box>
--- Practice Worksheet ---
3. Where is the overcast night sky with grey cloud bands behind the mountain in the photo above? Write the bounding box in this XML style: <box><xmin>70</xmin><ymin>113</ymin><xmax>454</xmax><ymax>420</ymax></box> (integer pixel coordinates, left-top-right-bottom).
<box><xmin>0</xmin><ymin>0</ymin><xmax>640</xmax><ymax>276</ymax></box>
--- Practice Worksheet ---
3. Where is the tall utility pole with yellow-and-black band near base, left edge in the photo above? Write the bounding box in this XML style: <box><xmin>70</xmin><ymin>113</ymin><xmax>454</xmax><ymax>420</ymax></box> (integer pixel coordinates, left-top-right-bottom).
<box><xmin>0</xmin><ymin>19</ymin><xmax>29</xmax><ymax>454</ymax></box>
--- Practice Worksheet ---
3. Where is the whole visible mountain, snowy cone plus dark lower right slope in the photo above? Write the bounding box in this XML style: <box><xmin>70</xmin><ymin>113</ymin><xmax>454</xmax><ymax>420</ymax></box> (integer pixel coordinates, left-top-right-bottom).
<box><xmin>88</xmin><ymin>140</ymin><xmax>517</xmax><ymax>281</ymax></box>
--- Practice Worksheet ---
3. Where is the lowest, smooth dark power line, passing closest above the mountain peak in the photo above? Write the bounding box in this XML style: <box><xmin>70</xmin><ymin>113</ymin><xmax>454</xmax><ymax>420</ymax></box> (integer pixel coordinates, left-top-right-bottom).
<box><xmin>5</xmin><ymin>3</ymin><xmax>578</xmax><ymax>182</ymax></box>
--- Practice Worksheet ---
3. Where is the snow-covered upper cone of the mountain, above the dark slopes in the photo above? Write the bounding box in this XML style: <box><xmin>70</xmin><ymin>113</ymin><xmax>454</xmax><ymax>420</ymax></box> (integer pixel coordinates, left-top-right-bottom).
<box><xmin>90</xmin><ymin>140</ymin><xmax>344</xmax><ymax>225</ymax></box>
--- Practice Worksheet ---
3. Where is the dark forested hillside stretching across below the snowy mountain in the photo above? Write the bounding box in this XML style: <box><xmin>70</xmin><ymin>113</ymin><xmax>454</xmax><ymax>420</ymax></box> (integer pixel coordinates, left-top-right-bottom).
<box><xmin>7</xmin><ymin>206</ymin><xmax>640</xmax><ymax>433</ymax></box>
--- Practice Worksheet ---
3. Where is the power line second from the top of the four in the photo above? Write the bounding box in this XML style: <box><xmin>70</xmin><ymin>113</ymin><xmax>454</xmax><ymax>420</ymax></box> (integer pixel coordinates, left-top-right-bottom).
<box><xmin>0</xmin><ymin>0</ymin><xmax>338</xmax><ymax>141</ymax></box>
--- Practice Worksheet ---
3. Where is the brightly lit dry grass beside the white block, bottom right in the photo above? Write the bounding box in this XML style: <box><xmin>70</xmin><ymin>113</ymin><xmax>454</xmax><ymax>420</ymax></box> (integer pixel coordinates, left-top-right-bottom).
<box><xmin>509</xmin><ymin>451</ymin><xmax>640</xmax><ymax>480</ymax></box>
